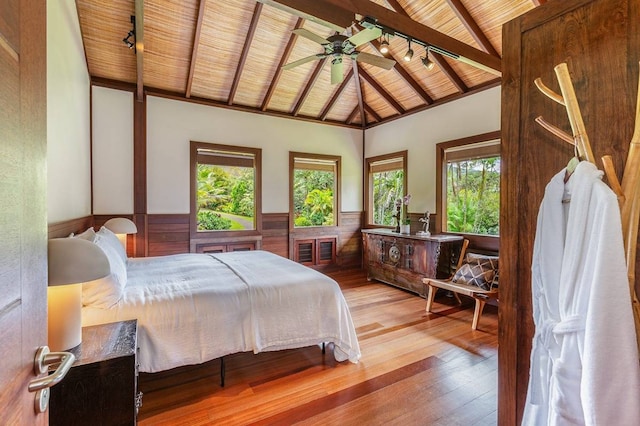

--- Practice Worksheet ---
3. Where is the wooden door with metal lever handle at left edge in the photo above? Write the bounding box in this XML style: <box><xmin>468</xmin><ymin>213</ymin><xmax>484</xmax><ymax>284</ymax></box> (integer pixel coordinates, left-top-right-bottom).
<box><xmin>0</xmin><ymin>0</ymin><xmax>48</xmax><ymax>425</ymax></box>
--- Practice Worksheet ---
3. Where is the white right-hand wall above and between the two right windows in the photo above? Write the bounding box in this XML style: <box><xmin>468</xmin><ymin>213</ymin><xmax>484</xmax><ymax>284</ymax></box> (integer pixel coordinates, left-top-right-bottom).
<box><xmin>365</xmin><ymin>87</ymin><xmax>500</xmax><ymax>213</ymax></box>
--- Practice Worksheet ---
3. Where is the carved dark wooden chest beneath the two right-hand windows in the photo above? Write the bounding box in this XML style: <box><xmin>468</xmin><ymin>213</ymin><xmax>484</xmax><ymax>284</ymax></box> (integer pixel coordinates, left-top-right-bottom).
<box><xmin>362</xmin><ymin>229</ymin><xmax>463</xmax><ymax>297</ymax></box>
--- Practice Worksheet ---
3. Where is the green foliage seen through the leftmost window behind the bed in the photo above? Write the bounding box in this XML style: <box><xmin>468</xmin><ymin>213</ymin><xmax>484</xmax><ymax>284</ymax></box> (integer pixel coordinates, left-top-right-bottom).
<box><xmin>197</xmin><ymin>164</ymin><xmax>255</xmax><ymax>231</ymax></box>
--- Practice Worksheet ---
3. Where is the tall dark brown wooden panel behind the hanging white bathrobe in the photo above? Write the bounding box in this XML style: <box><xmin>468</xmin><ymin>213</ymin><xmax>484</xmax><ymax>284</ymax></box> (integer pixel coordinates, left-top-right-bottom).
<box><xmin>498</xmin><ymin>0</ymin><xmax>640</xmax><ymax>425</ymax></box>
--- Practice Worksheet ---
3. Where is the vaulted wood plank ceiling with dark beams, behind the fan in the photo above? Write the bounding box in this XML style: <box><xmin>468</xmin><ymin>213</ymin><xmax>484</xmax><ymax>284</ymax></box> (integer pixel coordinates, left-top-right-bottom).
<box><xmin>76</xmin><ymin>0</ymin><xmax>544</xmax><ymax>128</ymax></box>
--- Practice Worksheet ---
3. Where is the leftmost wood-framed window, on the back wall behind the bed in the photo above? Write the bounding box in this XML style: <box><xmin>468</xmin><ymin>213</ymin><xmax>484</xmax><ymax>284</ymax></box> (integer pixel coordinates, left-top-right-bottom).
<box><xmin>191</xmin><ymin>142</ymin><xmax>261</xmax><ymax>234</ymax></box>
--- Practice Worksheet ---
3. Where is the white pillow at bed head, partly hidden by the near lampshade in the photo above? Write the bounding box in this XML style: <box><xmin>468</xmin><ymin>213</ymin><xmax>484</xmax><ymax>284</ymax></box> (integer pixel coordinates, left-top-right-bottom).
<box><xmin>82</xmin><ymin>235</ymin><xmax>127</xmax><ymax>309</ymax></box>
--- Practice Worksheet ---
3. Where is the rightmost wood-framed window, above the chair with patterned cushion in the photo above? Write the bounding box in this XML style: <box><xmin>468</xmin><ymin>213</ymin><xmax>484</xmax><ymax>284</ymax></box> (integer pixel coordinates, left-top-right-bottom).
<box><xmin>436</xmin><ymin>132</ymin><xmax>500</xmax><ymax>243</ymax></box>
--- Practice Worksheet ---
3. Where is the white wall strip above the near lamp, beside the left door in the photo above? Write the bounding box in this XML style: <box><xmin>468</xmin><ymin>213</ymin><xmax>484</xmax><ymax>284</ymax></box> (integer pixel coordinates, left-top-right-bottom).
<box><xmin>43</xmin><ymin>0</ymin><xmax>91</xmax><ymax>223</ymax></box>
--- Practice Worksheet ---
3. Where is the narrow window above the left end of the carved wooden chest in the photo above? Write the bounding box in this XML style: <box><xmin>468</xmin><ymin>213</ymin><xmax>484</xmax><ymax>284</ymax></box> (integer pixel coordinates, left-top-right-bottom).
<box><xmin>365</xmin><ymin>151</ymin><xmax>407</xmax><ymax>226</ymax></box>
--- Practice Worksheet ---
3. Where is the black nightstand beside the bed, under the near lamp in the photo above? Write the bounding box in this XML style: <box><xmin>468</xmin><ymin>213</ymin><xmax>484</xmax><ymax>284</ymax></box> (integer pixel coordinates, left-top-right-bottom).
<box><xmin>49</xmin><ymin>320</ymin><xmax>142</xmax><ymax>426</ymax></box>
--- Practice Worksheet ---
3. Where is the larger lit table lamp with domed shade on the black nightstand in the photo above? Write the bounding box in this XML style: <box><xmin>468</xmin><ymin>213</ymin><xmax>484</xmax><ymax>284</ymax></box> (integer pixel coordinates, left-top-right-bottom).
<box><xmin>47</xmin><ymin>238</ymin><xmax>111</xmax><ymax>352</ymax></box>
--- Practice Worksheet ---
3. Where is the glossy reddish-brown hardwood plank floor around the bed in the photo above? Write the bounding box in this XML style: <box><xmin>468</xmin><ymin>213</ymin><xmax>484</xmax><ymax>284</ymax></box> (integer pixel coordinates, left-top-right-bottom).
<box><xmin>138</xmin><ymin>270</ymin><xmax>498</xmax><ymax>426</ymax></box>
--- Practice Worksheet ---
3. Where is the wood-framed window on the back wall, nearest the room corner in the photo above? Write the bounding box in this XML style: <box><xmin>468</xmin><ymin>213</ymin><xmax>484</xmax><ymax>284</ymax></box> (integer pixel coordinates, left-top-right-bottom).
<box><xmin>289</xmin><ymin>152</ymin><xmax>340</xmax><ymax>229</ymax></box>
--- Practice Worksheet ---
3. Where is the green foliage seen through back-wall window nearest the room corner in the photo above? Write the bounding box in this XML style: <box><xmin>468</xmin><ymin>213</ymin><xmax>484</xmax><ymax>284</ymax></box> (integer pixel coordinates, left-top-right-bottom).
<box><xmin>293</xmin><ymin>169</ymin><xmax>335</xmax><ymax>226</ymax></box>
